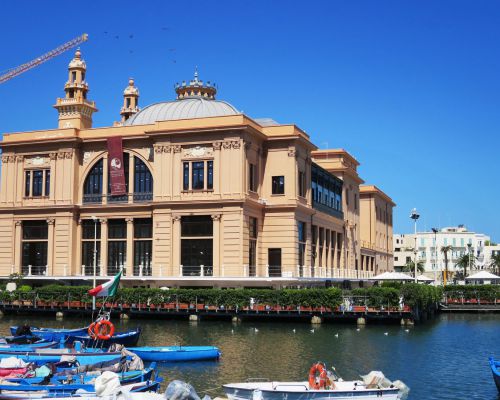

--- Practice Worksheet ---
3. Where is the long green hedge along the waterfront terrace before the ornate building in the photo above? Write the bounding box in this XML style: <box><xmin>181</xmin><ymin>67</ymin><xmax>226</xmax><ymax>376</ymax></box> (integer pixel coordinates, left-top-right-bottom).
<box><xmin>0</xmin><ymin>283</ymin><xmax>446</xmax><ymax>309</ymax></box>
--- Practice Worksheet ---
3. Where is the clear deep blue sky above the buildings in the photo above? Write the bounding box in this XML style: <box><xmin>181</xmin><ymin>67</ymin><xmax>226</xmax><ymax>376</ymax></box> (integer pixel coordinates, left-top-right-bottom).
<box><xmin>0</xmin><ymin>0</ymin><xmax>500</xmax><ymax>241</ymax></box>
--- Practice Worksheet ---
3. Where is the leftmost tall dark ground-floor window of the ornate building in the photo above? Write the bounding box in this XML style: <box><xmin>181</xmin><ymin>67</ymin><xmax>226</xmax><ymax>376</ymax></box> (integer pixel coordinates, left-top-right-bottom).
<box><xmin>21</xmin><ymin>221</ymin><xmax>49</xmax><ymax>275</ymax></box>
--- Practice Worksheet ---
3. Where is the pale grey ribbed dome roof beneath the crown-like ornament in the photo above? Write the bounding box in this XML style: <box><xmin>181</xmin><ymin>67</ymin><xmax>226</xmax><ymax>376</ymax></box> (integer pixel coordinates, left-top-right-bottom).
<box><xmin>125</xmin><ymin>97</ymin><xmax>240</xmax><ymax>125</ymax></box>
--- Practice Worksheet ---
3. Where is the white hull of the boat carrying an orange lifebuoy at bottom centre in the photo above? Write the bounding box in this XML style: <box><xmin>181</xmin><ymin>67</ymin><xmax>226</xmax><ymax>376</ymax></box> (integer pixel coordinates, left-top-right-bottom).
<box><xmin>223</xmin><ymin>382</ymin><xmax>399</xmax><ymax>400</ymax></box>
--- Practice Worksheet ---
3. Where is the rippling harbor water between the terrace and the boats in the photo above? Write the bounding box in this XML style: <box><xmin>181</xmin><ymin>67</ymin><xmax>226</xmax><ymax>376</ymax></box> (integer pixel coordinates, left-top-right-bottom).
<box><xmin>0</xmin><ymin>314</ymin><xmax>500</xmax><ymax>400</ymax></box>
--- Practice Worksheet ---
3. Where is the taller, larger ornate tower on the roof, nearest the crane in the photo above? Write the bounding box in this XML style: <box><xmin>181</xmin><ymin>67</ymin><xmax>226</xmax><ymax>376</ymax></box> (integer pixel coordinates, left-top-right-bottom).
<box><xmin>54</xmin><ymin>49</ymin><xmax>97</xmax><ymax>129</ymax></box>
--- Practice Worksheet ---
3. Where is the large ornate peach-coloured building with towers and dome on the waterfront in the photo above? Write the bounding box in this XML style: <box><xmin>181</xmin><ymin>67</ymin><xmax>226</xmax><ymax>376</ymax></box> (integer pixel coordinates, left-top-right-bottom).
<box><xmin>0</xmin><ymin>51</ymin><xmax>394</xmax><ymax>286</ymax></box>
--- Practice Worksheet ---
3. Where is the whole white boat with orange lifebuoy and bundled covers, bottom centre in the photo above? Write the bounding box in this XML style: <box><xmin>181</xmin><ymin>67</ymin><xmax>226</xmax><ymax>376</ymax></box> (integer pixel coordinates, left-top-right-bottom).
<box><xmin>223</xmin><ymin>363</ymin><xmax>409</xmax><ymax>400</ymax></box>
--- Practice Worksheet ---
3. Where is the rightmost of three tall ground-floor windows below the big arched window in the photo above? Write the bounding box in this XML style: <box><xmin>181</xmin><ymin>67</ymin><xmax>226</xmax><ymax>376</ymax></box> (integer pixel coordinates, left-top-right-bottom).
<box><xmin>133</xmin><ymin>218</ymin><xmax>153</xmax><ymax>276</ymax></box>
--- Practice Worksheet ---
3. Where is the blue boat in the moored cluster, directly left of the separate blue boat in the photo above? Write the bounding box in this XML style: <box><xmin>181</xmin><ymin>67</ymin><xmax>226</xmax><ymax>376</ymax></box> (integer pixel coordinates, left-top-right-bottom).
<box><xmin>0</xmin><ymin>349</ymin><xmax>121</xmax><ymax>365</ymax></box>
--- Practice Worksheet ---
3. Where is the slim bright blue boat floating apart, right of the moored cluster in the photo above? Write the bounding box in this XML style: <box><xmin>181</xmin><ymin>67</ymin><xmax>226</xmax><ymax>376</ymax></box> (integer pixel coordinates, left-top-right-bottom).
<box><xmin>128</xmin><ymin>346</ymin><xmax>221</xmax><ymax>362</ymax></box>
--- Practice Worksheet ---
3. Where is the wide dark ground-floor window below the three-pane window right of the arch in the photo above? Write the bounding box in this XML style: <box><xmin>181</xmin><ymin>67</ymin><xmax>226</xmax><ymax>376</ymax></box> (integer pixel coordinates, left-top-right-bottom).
<box><xmin>181</xmin><ymin>215</ymin><xmax>213</xmax><ymax>276</ymax></box>
